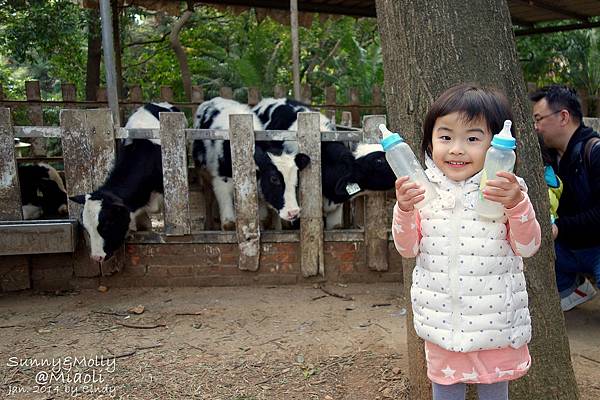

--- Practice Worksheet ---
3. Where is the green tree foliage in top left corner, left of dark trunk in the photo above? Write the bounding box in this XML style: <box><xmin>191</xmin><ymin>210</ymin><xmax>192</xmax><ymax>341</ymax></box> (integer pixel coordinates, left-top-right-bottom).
<box><xmin>0</xmin><ymin>0</ymin><xmax>87</xmax><ymax>99</ymax></box>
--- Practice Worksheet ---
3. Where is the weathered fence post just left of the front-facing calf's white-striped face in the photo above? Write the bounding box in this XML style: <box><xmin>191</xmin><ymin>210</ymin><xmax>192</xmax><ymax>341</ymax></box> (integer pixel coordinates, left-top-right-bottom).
<box><xmin>229</xmin><ymin>114</ymin><xmax>260</xmax><ymax>271</ymax></box>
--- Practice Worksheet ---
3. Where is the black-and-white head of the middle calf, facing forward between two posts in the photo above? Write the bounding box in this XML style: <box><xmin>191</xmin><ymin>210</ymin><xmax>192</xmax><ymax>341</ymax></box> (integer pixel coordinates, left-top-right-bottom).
<box><xmin>254</xmin><ymin>146</ymin><xmax>310</xmax><ymax>221</ymax></box>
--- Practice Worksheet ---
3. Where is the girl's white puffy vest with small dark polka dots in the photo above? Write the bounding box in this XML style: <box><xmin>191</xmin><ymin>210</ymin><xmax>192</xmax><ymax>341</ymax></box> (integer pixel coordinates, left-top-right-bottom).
<box><xmin>411</xmin><ymin>160</ymin><xmax>531</xmax><ymax>352</ymax></box>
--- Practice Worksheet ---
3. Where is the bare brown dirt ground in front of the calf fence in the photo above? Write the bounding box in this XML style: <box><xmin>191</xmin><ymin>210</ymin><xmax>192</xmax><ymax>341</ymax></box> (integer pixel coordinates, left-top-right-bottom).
<box><xmin>0</xmin><ymin>284</ymin><xmax>600</xmax><ymax>400</ymax></box>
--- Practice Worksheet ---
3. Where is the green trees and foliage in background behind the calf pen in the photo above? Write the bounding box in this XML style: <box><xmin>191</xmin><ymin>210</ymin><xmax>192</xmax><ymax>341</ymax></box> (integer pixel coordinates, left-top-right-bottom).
<box><xmin>0</xmin><ymin>0</ymin><xmax>600</xmax><ymax>115</ymax></box>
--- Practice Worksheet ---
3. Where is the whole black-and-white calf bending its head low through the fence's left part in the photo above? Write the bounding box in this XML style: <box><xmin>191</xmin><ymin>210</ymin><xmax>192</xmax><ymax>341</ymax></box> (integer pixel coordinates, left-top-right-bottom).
<box><xmin>71</xmin><ymin>103</ymin><xmax>178</xmax><ymax>262</ymax></box>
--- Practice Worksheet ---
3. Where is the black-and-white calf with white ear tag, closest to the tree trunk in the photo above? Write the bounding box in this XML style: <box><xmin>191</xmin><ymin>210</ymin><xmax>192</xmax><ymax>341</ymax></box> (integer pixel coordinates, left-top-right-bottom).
<box><xmin>252</xmin><ymin>98</ymin><xmax>396</xmax><ymax>229</ymax></box>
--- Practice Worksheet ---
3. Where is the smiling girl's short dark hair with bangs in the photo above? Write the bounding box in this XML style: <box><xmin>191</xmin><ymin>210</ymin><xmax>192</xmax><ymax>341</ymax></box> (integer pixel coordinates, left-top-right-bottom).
<box><xmin>421</xmin><ymin>84</ymin><xmax>515</xmax><ymax>156</ymax></box>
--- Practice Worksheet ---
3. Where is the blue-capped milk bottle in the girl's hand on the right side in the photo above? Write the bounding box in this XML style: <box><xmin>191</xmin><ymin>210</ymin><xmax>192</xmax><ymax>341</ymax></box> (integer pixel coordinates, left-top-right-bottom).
<box><xmin>475</xmin><ymin>120</ymin><xmax>517</xmax><ymax>218</ymax></box>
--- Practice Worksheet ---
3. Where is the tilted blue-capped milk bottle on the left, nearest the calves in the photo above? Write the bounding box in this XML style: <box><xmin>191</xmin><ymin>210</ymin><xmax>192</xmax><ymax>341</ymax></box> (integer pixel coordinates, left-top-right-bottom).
<box><xmin>379</xmin><ymin>124</ymin><xmax>436</xmax><ymax>208</ymax></box>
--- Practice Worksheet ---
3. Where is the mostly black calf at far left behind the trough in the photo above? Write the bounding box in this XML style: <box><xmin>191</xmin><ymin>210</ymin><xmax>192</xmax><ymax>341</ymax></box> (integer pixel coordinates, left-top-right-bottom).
<box><xmin>19</xmin><ymin>163</ymin><xmax>67</xmax><ymax>219</ymax></box>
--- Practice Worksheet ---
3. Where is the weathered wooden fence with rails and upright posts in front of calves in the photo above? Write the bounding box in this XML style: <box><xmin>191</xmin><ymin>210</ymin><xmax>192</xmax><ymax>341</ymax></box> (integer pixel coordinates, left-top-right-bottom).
<box><xmin>0</xmin><ymin>108</ymin><xmax>389</xmax><ymax>277</ymax></box>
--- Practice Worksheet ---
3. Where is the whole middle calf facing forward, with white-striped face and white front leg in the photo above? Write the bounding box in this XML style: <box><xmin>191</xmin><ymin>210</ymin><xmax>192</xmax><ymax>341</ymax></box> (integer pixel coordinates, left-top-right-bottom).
<box><xmin>193</xmin><ymin>97</ymin><xmax>310</xmax><ymax>230</ymax></box>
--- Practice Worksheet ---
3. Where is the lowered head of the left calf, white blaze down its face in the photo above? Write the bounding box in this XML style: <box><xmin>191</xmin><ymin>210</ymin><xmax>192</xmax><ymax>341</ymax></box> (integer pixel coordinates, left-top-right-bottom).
<box><xmin>70</xmin><ymin>192</ymin><xmax>131</xmax><ymax>262</ymax></box>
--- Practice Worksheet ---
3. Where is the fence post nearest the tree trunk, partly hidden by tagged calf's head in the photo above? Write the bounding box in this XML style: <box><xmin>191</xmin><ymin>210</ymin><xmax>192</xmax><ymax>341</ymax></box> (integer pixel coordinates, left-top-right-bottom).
<box><xmin>363</xmin><ymin>115</ymin><xmax>390</xmax><ymax>271</ymax></box>
